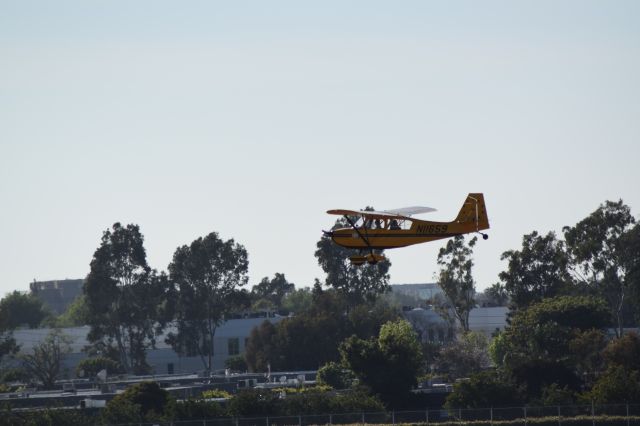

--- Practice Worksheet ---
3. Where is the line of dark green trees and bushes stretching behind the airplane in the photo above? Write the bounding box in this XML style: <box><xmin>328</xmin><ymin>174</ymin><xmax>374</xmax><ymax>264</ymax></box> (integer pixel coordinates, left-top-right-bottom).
<box><xmin>0</xmin><ymin>201</ymin><xmax>640</xmax><ymax>408</ymax></box>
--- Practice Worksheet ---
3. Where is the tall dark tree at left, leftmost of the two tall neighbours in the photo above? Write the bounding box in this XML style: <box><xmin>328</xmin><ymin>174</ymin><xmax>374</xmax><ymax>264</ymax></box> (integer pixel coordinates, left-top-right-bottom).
<box><xmin>83</xmin><ymin>223</ymin><xmax>167</xmax><ymax>374</ymax></box>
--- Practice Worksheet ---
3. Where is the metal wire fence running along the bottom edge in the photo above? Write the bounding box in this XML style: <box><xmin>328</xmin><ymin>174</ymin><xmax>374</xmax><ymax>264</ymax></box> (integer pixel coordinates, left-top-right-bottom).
<box><xmin>114</xmin><ymin>404</ymin><xmax>640</xmax><ymax>426</ymax></box>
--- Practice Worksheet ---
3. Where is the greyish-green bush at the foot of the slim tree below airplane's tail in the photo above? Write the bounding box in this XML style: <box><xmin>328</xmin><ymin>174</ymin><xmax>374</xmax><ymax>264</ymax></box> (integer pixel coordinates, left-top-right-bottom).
<box><xmin>435</xmin><ymin>331</ymin><xmax>489</xmax><ymax>379</ymax></box>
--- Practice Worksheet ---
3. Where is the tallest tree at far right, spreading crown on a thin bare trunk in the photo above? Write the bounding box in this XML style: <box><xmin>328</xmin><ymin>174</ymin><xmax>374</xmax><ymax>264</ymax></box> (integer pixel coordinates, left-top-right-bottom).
<box><xmin>563</xmin><ymin>200</ymin><xmax>640</xmax><ymax>336</ymax></box>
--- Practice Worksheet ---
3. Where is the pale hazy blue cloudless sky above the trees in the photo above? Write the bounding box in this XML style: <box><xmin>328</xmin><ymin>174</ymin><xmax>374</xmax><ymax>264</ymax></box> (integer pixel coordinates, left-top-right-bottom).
<box><xmin>0</xmin><ymin>0</ymin><xmax>640</xmax><ymax>293</ymax></box>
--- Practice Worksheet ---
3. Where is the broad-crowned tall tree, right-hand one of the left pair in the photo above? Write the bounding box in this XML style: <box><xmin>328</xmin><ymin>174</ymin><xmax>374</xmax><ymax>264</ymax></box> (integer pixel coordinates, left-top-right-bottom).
<box><xmin>167</xmin><ymin>232</ymin><xmax>249</xmax><ymax>371</ymax></box>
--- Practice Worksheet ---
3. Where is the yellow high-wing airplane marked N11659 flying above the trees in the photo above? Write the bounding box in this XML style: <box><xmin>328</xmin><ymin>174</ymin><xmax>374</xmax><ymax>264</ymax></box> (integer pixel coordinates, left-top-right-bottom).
<box><xmin>323</xmin><ymin>193</ymin><xmax>489</xmax><ymax>265</ymax></box>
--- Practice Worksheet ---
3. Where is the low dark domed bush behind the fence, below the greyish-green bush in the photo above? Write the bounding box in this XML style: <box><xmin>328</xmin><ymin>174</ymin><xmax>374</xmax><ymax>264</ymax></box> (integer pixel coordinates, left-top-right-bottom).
<box><xmin>445</xmin><ymin>371</ymin><xmax>522</xmax><ymax>409</ymax></box>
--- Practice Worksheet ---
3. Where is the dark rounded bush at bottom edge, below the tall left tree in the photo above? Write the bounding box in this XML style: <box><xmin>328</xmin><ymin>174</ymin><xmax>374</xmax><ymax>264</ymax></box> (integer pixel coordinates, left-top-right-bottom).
<box><xmin>102</xmin><ymin>382</ymin><xmax>172</xmax><ymax>423</ymax></box>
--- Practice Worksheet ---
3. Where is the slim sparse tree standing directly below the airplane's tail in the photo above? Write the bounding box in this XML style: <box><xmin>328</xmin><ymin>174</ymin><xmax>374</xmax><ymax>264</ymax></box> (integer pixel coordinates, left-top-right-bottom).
<box><xmin>438</xmin><ymin>235</ymin><xmax>478</xmax><ymax>332</ymax></box>
